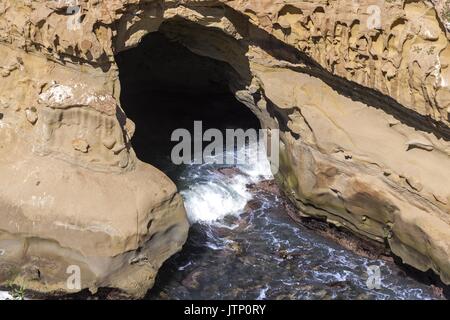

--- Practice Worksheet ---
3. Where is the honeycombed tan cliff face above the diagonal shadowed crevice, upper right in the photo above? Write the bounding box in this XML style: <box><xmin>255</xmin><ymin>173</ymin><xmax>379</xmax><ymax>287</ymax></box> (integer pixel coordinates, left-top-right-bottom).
<box><xmin>230</xmin><ymin>0</ymin><xmax>450</xmax><ymax>124</ymax></box>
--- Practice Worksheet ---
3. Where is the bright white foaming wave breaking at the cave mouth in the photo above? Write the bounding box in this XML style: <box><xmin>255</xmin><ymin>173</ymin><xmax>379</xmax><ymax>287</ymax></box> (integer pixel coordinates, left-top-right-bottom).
<box><xmin>181</xmin><ymin>143</ymin><xmax>272</xmax><ymax>223</ymax></box>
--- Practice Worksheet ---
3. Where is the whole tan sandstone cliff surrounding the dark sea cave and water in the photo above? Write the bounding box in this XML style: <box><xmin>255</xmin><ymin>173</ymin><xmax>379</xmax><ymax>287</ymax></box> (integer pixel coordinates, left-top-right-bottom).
<box><xmin>0</xmin><ymin>0</ymin><xmax>450</xmax><ymax>297</ymax></box>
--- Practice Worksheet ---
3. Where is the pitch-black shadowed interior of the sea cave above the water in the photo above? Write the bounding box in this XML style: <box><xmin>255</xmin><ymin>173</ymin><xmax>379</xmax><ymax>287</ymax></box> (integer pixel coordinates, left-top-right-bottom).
<box><xmin>116</xmin><ymin>32</ymin><xmax>260</xmax><ymax>180</ymax></box>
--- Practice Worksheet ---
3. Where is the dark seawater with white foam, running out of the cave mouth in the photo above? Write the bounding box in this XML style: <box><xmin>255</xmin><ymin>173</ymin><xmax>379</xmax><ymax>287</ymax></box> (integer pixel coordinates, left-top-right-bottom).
<box><xmin>148</xmin><ymin>145</ymin><xmax>436</xmax><ymax>299</ymax></box>
